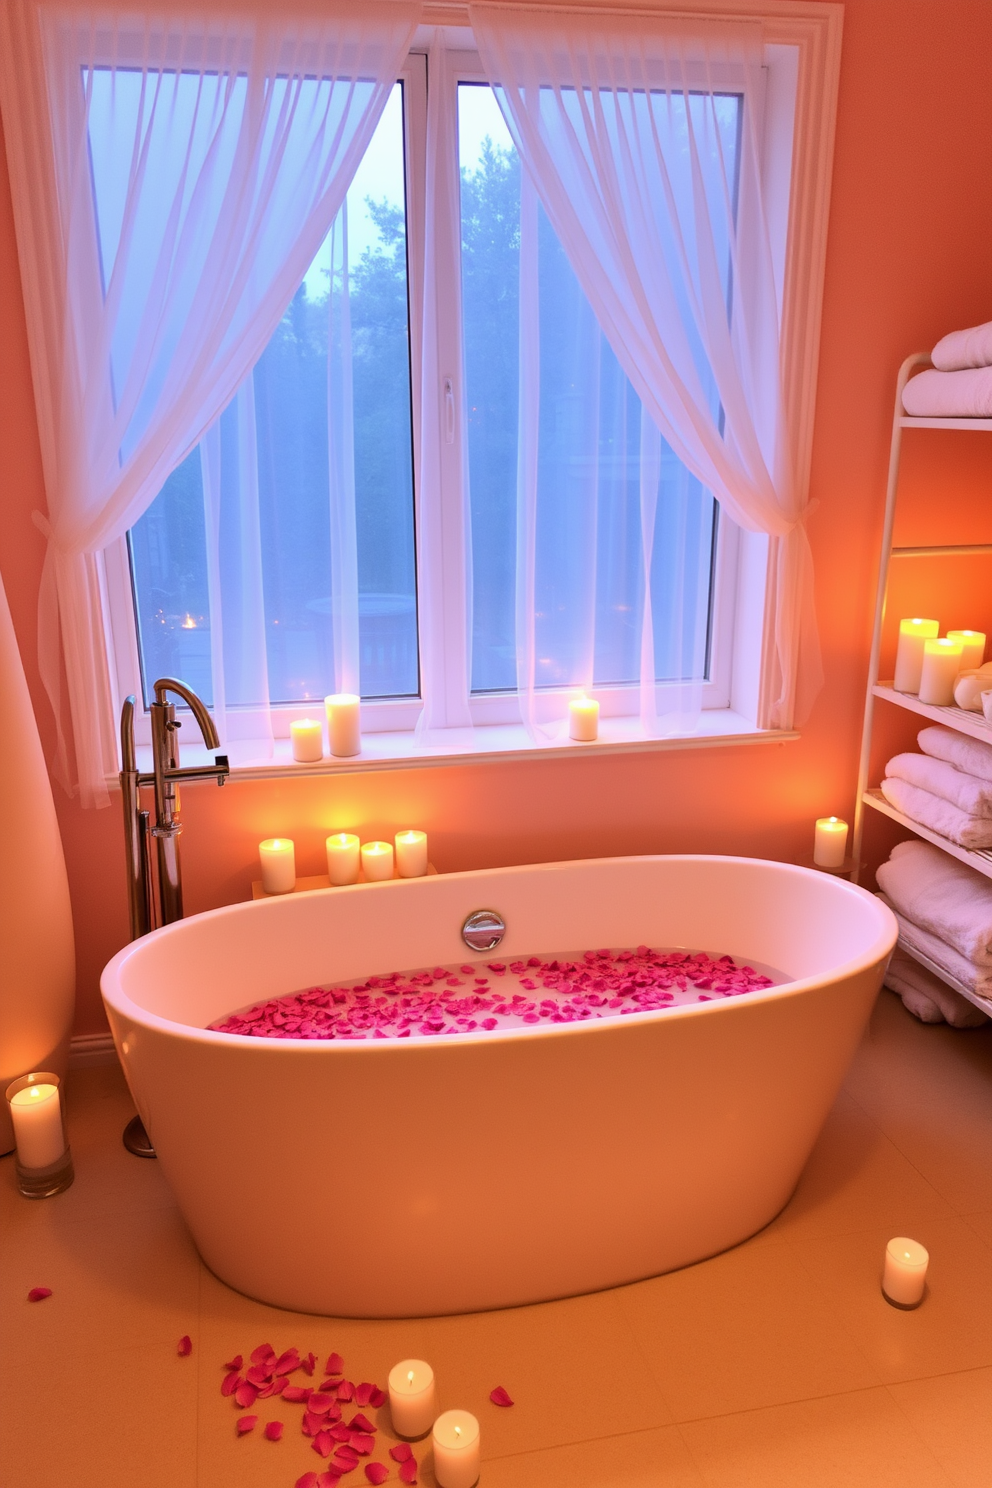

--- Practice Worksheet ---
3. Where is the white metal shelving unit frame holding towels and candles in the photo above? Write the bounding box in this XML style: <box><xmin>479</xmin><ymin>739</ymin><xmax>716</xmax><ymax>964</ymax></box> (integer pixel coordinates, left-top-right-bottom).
<box><xmin>852</xmin><ymin>351</ymin><xmax>992</xmax><ymax>1013</ymax></box>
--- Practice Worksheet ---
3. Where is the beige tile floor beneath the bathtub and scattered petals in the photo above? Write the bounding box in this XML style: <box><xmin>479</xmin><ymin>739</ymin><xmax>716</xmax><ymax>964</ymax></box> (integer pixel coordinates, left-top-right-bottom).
<box><xmin>0</xmin><ymin>992</ymin><xmax>992</xmax><ymax>1488</ymax></box>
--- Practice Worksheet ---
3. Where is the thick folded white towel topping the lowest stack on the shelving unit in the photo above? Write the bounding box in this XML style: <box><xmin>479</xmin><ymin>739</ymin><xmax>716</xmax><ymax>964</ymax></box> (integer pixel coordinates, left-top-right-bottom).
<box><xmin>875</xmin><ymin>841</ymin><xmax>992</xmax><ymax>972</ymax></box>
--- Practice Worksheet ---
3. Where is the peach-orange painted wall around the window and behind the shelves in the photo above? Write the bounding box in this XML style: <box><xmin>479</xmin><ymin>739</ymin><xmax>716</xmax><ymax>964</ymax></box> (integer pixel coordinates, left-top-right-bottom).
<box><xmin>0</xmin><ymin>0</ymin><xmax>992</xmax><ymax>1033</ymax></box>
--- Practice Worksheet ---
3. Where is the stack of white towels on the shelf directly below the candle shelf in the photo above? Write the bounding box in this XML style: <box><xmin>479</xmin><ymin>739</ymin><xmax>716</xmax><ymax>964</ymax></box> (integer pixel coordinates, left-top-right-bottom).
<box><xmin>882</xmin><ymin>725</ymin><xmax>992</xmax><ymax>848</ymax></box>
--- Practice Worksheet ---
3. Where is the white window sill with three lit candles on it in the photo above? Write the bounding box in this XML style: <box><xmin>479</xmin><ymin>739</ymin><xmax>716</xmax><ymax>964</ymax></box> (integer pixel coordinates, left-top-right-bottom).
<box><xmin>116</xmin><ymin>708</ymin><xmax>799</xmax><ymax>784</ymax></box>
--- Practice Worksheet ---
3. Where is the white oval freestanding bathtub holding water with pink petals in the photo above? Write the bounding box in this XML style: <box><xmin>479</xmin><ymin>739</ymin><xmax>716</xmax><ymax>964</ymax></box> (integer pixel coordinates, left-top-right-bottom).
<box><xmin>103</xmin><ymin>856</ymin><xmax>897</xmax><ymax>1317</ymax></box>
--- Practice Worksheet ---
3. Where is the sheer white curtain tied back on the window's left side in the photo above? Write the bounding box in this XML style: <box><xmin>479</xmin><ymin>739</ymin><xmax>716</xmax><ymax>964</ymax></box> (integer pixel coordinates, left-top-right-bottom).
<box><xmin>0</xmin><ymin>0</ymin><xmax>419</xmax><ymax>804</ymax></box>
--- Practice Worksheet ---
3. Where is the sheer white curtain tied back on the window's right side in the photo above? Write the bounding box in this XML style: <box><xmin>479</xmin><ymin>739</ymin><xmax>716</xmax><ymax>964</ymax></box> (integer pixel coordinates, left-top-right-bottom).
<box><xmin>468</xmin><ymin>4</ymin><xmax>821</xmax><ymax>726</ymax></box>
